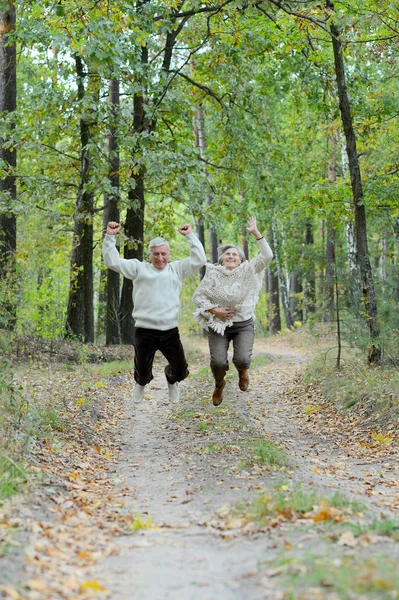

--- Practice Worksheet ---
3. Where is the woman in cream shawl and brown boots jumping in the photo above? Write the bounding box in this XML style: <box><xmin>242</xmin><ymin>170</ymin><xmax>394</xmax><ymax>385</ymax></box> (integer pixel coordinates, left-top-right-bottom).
<box><xmin>193</xmin><ymin>217</ymin><xmax>273</xmax><ymax>406</ymax></box>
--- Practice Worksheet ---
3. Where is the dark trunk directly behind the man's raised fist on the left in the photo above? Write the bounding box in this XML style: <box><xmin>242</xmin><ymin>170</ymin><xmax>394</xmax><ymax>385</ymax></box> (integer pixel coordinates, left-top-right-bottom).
<box><xmin>100</xmin><ymin>79</ymin><xmax>121</xmax><ymax>344</ymax></box>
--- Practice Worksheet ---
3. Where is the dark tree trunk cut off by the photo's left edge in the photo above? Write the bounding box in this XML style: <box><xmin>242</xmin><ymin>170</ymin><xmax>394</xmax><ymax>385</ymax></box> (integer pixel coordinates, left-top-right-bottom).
<box><xmin>0</xmin><ymin>2</ymin><xmax>17</xmax><ymax>331</ymax></box>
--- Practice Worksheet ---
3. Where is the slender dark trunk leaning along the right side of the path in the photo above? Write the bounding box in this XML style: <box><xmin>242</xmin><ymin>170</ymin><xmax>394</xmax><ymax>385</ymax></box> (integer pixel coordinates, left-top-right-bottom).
<box><xmin>326</xmin><ymin>0</ymin><xmax>381</xmax><ymax>363</ymax></box>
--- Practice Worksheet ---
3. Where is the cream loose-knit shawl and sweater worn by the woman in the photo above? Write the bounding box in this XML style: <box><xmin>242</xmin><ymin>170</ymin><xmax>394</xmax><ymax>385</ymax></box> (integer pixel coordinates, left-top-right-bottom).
<box><xmin>193</xmin><ymin>238</ymin><xmax>273</xmax><ymax>335</ymax></box>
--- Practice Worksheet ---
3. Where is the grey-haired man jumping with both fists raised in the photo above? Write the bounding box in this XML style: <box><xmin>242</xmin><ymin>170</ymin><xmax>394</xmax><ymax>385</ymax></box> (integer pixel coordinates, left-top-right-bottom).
<box><xmin>103</xmin><ymin>221</ymin><xmax>206</xmax><ymax>402</ymax></box>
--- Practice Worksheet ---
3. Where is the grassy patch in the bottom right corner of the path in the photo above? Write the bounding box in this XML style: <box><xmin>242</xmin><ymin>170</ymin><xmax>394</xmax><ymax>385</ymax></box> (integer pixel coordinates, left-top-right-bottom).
<box><xmin>282</xmin><ymin>556</ymin><xmax>399</xmax><ymax>600</ymax></box>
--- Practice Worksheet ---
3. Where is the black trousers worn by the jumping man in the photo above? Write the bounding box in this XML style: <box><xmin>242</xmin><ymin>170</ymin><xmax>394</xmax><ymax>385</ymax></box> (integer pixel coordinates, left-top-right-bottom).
<box><xmin>134</xmin><ymin>327</ymin><xmax>189</xmax><ymax>385</ymax></box>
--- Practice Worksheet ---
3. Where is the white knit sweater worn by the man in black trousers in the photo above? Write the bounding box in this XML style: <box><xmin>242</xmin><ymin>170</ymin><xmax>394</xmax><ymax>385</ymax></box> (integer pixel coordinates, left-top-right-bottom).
<box><xmin>103</xmin><ymin>233</ymin><xmax>206</xmax><ymax>331</ymax></box>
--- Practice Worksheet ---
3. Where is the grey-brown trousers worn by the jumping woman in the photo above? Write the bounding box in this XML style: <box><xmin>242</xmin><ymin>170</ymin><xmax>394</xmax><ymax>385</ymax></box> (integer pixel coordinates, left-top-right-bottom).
<box><xmin>208</xmin><ymin>319</ymin><xmax>255</xmax><ymax>387</ymax></box>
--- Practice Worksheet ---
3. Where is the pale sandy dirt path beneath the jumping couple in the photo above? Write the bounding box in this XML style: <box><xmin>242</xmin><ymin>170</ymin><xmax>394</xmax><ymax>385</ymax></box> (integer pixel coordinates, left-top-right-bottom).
<box><xmin>86</xmin><ymin>345</ymin><xmax>398</xmax><ymax>600</ymax></box>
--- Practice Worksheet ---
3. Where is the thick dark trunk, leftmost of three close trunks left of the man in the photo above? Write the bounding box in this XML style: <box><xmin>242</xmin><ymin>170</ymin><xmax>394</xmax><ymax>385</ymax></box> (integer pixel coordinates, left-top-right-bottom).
<box><xmin>66</xmin><ymin>56</ymin><xmax>99</xmax><ymax>343</ymax></box>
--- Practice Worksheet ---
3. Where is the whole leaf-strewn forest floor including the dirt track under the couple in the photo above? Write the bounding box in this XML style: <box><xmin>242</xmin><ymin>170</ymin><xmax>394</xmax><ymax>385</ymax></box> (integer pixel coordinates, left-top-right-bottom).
<box><xmin>0</xmin><ymin>336</ymin><xmax>399</xmax><ymax>600</ymax></box>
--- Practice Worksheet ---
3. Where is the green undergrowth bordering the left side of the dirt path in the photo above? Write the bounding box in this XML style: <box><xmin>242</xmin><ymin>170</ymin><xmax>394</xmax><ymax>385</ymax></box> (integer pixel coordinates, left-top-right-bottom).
<box><xmin>0</xmin><ymin>326</ymin><xmax>133</xmax><ymax>502</ymax></box>
